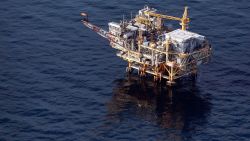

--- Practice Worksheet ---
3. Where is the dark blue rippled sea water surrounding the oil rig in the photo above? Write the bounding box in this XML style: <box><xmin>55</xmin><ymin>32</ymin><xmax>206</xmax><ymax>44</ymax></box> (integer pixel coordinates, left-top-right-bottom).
<box><xmin>0</xmin><ymin>0</ymin><xmax>250</xmax><ymax>141</ymax></box>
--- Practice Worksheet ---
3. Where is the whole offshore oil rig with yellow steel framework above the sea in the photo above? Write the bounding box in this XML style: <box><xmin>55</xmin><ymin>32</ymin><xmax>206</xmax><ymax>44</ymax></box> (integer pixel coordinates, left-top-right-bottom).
<box><xmin>81</xmin><ymin>6</ymin><xmax>212</xmax><ymax>85</ymax></box>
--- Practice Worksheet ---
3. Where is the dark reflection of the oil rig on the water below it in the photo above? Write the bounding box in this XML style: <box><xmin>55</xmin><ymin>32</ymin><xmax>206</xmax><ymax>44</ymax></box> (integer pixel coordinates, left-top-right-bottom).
<box><xmin>108</xmin><ymin>76</ymin><xmax>210</xmax><ymax>130</ymax></box>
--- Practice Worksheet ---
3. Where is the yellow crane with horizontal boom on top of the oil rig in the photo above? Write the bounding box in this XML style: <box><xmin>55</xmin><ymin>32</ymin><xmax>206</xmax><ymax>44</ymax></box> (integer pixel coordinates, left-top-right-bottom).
<box><xmin>144</xmin><ymin>7</ymin><xmax>190</xmax><ymax>30</ymax></box>
